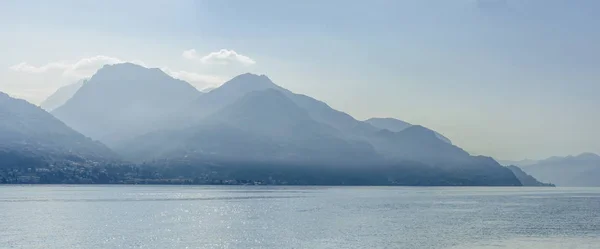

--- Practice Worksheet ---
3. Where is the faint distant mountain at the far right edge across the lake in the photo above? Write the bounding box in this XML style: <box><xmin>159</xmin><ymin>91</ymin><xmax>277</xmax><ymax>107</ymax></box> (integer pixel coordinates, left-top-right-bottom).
<box><xmin>523</xmin><ymin>153</ymin><xmax>600</xmax><ymax>187</ymax></box>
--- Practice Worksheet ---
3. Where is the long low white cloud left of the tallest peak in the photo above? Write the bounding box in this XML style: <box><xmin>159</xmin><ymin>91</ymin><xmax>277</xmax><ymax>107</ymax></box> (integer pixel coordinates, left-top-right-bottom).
<box><xmin>10</xmin><ymin>55</ymin><xmax>126</xmax><ymax>79</ymax></box>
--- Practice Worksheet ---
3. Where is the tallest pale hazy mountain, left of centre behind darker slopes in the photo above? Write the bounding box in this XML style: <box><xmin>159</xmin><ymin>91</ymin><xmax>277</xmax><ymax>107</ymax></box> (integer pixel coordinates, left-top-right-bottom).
<box><xmin>52</xmin><ymin>63</ymin><xmax>201</xmax><ymax>146</ymax></box>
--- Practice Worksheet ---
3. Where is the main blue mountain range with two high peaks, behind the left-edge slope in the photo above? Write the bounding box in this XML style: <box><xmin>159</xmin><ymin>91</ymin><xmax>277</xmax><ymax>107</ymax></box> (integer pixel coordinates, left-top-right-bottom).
<box><xmin>1</xmin><ymin>63</ymin><xmax>540</xmax><ymax>186</ymax></box>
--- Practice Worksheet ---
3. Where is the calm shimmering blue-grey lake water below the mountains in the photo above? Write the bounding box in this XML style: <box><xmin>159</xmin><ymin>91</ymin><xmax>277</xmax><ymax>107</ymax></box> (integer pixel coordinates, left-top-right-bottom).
<box><xmin>0</xmin><ymin>186</ymin><xmax>600</xmax><ymax>249</ymax></box>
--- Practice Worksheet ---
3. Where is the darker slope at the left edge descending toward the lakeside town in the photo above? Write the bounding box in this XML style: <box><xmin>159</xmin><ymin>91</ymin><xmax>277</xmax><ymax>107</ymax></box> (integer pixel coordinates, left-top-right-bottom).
<box><xmin>0</xmin><ymin>92</ymin><xmax>115</xmax><ymax>167</ymax></box>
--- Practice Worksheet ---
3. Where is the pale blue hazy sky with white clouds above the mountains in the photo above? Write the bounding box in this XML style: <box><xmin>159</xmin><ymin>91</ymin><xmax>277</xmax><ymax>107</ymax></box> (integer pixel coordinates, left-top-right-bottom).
<box><xmin>0</xmin><ymin>0</ymin><xmax>600</xmax><ymax>160</ymax></box>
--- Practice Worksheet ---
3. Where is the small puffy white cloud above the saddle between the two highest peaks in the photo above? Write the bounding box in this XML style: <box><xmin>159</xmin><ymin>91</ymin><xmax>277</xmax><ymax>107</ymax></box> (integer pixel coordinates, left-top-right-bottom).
<box><xmin>182</xmin><ymin>49</ymin><xmax>256</xmax><ymax>66</ymax></box>
